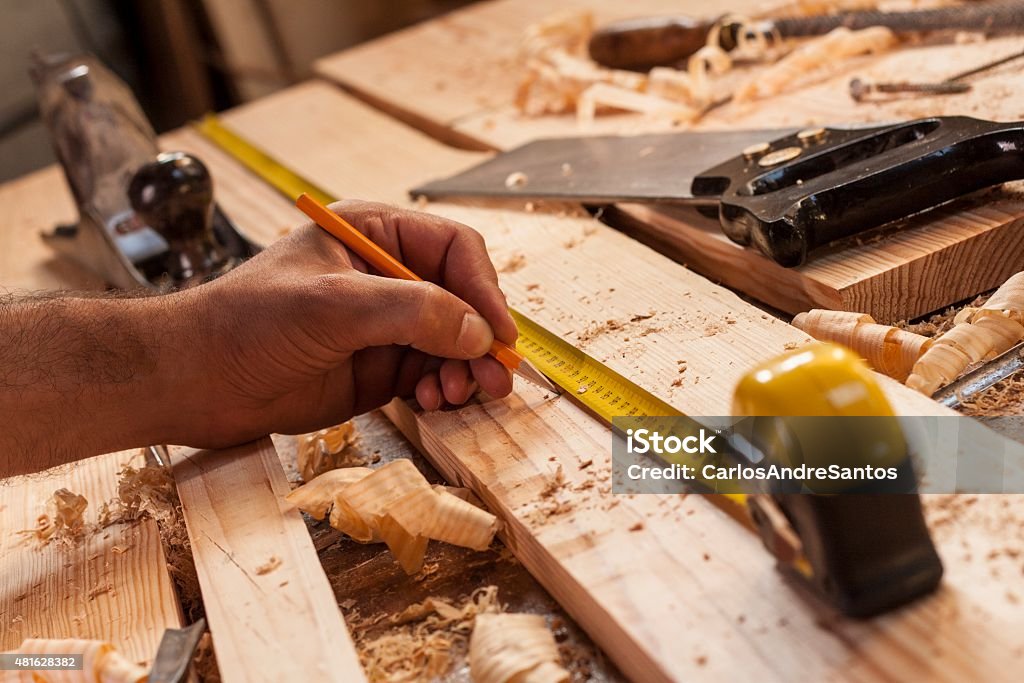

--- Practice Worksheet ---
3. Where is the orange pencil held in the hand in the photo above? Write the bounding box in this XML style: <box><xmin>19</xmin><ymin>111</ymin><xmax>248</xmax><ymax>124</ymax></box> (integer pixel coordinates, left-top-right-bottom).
<box><xmin>295</xmin><ymin>193</ymin><xmax>558</xmax><ymax>392</ymax></box>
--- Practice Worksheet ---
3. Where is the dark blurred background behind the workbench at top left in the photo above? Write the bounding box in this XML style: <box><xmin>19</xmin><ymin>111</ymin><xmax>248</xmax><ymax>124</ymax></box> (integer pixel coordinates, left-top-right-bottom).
<box><xmin>0</xmin><ymin>0</ymin><xmax>470</xmax><ymax>181</ymax></box>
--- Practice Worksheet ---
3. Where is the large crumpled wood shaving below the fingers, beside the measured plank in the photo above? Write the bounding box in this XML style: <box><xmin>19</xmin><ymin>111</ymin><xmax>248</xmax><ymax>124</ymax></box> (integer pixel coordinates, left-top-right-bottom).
<box><xmin>288</xmin><ymin>460</ymin><xmax>498</xmax><ymax>574</ymax></box>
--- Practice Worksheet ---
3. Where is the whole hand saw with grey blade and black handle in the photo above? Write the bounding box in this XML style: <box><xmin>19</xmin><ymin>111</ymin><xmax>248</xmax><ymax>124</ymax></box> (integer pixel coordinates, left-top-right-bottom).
<box><xmin>411</xmin><ymin>117</ymin><xmax>1024</xmax><ymax>266</ymax></box>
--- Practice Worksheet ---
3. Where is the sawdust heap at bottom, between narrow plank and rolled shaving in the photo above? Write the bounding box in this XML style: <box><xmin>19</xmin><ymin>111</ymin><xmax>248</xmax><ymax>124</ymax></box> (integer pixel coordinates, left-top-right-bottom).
<box><xmin>345</xmin><ymin>586</ymin><xmax>505</xmax><ymax>683</ymax></box>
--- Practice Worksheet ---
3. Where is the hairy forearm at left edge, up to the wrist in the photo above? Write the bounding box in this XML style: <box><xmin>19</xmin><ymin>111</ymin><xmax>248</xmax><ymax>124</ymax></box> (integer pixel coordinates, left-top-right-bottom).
<box><xmin>0</xmin><ymin>294</ymin><xmax>205</xmax><ymax>476</ymax></box>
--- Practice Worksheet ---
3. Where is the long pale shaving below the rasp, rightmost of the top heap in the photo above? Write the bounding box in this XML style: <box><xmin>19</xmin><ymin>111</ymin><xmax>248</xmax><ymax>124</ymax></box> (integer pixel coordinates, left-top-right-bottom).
<box><xmin>734</xmin><ymin>27</ymin><xmax>897</xmax><ymax>101</ymax></box>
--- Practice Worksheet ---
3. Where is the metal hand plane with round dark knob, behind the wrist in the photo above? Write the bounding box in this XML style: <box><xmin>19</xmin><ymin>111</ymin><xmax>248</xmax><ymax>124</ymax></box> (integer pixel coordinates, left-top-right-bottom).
<box><xmin>31</xmin><ymin>55</ymin><xmax>258</xmax><ymax>290</ymax></box>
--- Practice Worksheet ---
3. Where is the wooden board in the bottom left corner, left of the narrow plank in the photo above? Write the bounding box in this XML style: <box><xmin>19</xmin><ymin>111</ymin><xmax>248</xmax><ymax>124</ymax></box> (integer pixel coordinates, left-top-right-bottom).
<box><xmin>0</xmin><ymin>451</ymin><xmax>182</xmax><ymax>663</ymax></box>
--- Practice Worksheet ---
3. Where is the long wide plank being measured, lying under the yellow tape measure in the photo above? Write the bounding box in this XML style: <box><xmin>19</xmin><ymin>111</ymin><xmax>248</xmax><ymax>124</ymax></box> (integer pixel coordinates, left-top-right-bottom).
<box><xmin>216</xmin><ymin>85</ymin><xmax>1024</xmax><ymax>681</ymax></box>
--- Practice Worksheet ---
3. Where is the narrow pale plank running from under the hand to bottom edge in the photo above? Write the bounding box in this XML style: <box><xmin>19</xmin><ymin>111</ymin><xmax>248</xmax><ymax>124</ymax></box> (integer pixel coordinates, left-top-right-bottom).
<box><xmin>171</xmin><ymin>437</ymin><xmax>366</xmax><ymax>683</ymax></box>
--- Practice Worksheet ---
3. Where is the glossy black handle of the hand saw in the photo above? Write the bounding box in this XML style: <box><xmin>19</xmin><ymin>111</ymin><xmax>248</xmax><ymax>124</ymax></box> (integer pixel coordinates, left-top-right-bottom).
<box><xmin>691</xmin><ymin>117</ymin><xmax>1024</xmax><ymax>266</ymax></box>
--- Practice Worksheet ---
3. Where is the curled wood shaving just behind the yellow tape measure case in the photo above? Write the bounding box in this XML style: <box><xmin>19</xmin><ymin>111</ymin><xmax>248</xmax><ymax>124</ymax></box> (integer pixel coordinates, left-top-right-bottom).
<box><xmin>793</xmin><ymin>308</ymin><xmax>933</xmax><ymax>382</ymax></box>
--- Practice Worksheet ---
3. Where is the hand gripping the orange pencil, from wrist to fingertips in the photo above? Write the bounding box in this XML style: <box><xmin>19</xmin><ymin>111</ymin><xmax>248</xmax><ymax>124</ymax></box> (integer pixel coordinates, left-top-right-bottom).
<box><xmin>181</xmin><ymin>201</ymin><xmax>518</xmax><ymax>446</ymax></box>
